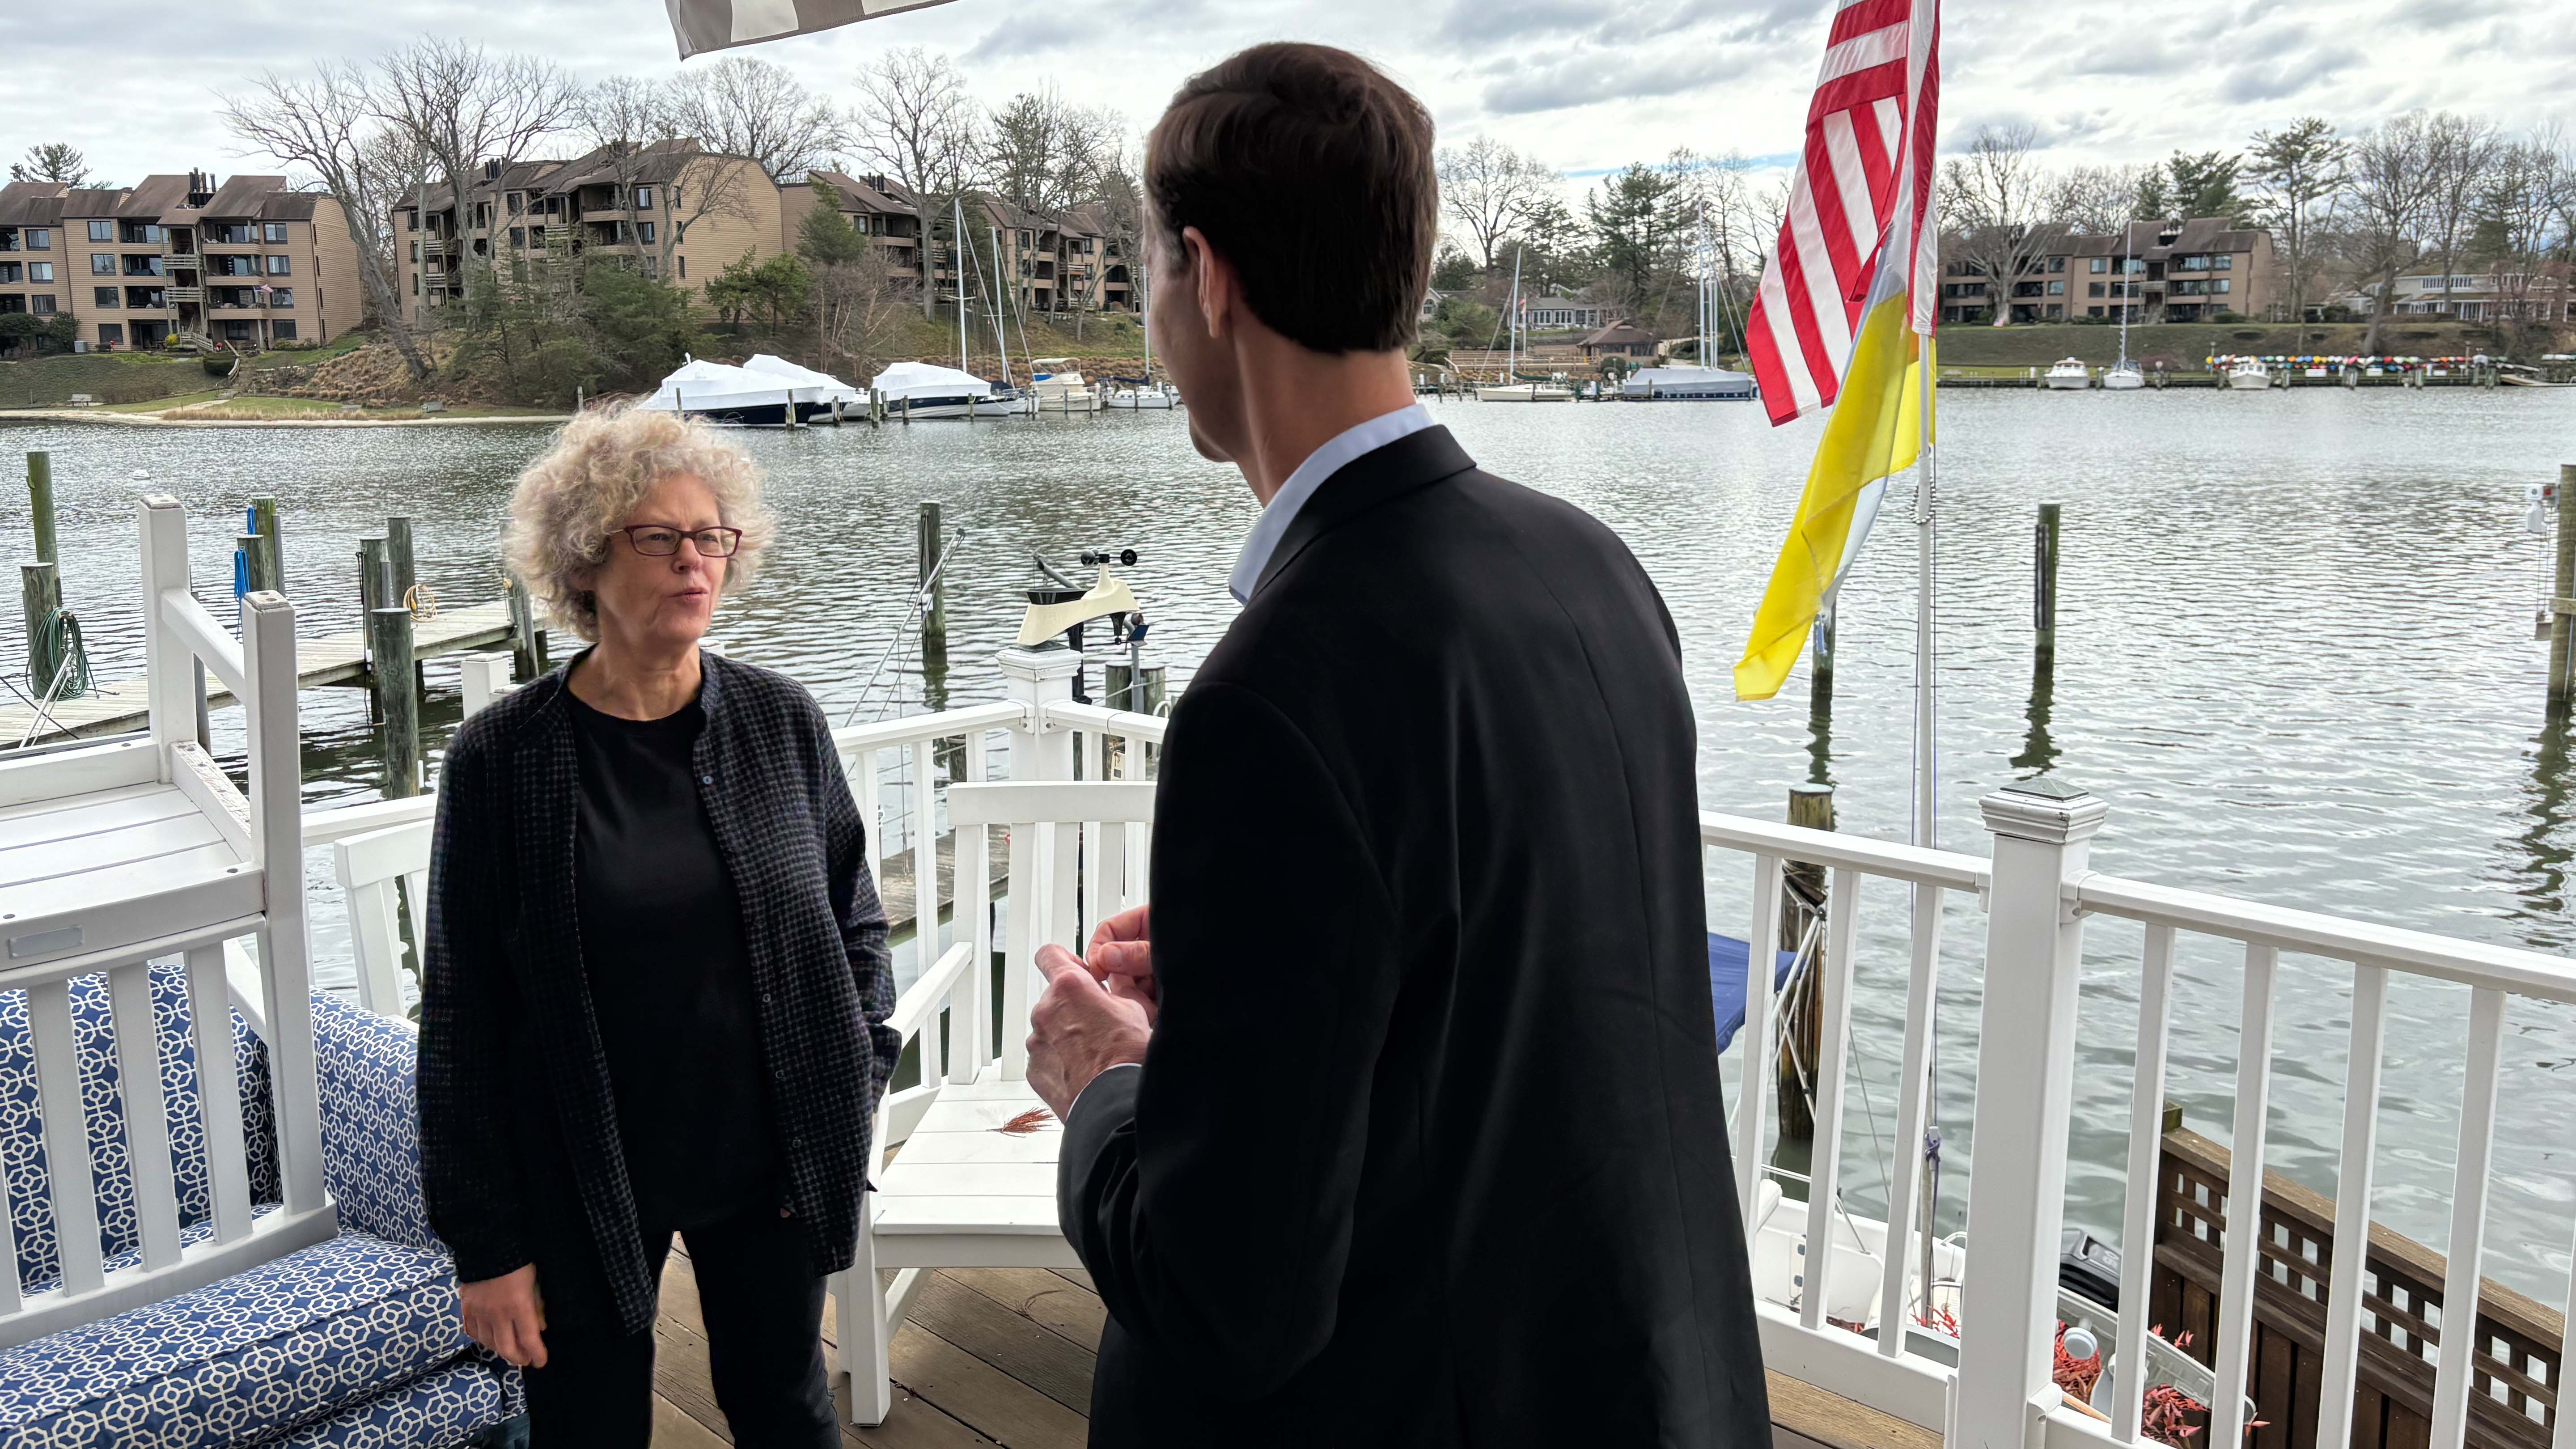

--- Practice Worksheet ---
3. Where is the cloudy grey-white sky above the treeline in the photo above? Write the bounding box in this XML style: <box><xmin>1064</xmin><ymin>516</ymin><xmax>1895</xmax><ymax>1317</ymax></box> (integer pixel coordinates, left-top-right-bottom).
<box><xmin>0</xmin><ymin>0</ymin><xmax>2576</xmax><ymax>201</ymax></box>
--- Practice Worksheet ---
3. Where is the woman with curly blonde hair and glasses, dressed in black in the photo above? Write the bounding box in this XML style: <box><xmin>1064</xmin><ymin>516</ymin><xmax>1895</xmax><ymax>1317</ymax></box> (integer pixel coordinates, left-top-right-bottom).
<box><xmin>420</xmin><ymin>399</ymin><xmax>899</xmax><ymax>1449</ymax></box>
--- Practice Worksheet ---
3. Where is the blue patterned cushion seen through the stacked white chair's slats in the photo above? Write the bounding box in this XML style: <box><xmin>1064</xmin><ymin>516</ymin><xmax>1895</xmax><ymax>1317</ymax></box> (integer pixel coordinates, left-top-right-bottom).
<box><xmin>0</xmin><ymin>967</ymin><xmax>278</xmax><ymax>1287</ymax></box>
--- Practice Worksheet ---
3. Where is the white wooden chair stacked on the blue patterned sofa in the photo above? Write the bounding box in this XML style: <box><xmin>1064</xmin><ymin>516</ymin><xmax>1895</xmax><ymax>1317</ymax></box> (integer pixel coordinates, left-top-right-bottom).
<box><xmin>0</xmin><ymin>498</ymin><xmax>338</xmax><ymax>1348</ymax></box>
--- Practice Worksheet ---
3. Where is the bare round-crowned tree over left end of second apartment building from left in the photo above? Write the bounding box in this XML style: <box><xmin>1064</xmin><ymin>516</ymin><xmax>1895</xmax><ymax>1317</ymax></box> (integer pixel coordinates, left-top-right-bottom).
<box><xmin>371</xmin><ymin>36</ymin><xmax>582</xmax><ymax>296</ymax></box>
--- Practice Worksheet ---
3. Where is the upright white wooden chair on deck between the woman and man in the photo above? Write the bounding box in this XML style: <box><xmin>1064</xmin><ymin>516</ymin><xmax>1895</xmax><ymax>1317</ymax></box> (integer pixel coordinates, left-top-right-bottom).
<box><xmin>832</xmin><ymin>781</ymin><xmax>1154</xmax><ymax>1426</ymax></box>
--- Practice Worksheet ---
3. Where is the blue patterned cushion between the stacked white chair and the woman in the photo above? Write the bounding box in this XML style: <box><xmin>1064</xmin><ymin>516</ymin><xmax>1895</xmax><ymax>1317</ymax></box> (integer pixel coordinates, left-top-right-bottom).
<box><xmin>314</xmin><ymin>993</ymin><xmax>438</xmax><ymax>1248</ymax></box>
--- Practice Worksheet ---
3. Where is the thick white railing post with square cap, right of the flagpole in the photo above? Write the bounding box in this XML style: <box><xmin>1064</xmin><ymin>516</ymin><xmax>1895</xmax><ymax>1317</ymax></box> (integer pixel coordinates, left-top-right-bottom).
<box><xmin>1953</xmin><ymin>779</ymin><xmax>2105</xmax><ymax>1449</ymax></box>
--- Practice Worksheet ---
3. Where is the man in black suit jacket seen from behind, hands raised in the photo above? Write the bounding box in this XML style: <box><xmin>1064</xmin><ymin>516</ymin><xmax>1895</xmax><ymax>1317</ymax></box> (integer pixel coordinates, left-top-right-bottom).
<box><xmin>1028</xmin><ymin>44</ymin><xmax>1770</xmax><ymax>1449</ymax></box>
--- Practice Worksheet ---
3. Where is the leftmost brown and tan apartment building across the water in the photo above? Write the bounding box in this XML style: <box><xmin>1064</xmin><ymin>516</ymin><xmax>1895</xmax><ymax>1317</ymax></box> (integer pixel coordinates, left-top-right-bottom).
<box><xmin>0</xmin><ymin>170</ymin><xmax>366</xmax><ymax>351</ymax></box>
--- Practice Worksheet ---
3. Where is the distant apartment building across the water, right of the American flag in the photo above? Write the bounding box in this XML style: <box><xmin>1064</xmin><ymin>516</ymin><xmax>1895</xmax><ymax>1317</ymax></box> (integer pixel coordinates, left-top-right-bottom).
<box><xmin>1940</xmin><ymin>216</ymin><xmax>2288</xmax><ymax>322</ymax></box>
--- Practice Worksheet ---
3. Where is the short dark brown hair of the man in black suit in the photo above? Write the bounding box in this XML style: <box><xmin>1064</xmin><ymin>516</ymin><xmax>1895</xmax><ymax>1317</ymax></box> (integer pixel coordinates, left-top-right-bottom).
<box><xmin>1144</xmin><ymin>41</ymin><xmax>1440</xmax><ymax>353</ymax></box>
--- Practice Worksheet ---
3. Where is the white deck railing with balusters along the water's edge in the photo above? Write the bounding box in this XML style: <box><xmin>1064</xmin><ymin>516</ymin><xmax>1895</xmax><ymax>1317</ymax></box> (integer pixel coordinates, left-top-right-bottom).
<box><xmin>282</xmin><ymin>650</ymin><xmax>2576</xmax><ymax>1449</ymax></box>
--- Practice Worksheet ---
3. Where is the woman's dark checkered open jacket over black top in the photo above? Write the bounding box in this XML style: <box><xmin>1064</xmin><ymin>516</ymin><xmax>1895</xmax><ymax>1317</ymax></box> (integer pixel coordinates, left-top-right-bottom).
<box><xmin>420</xmin><ymin>655</ymin><xmax>902</xmax><ymax>1333</ymax></box>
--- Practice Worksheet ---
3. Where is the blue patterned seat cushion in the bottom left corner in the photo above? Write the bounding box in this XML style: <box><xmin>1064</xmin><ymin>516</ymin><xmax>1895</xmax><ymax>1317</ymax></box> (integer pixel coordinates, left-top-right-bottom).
<box><xmin>0</xmin><ymin>1233</ymin><xmax>482</xmax><ymax>1449</ymax></box>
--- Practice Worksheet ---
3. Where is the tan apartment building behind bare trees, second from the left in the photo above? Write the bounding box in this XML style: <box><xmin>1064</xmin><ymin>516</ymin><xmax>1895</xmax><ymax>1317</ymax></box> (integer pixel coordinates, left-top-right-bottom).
<box><xmin>394</xmin><ymin>139</ymin><xmax>801</xmax><ymax>317</ymax></box>
